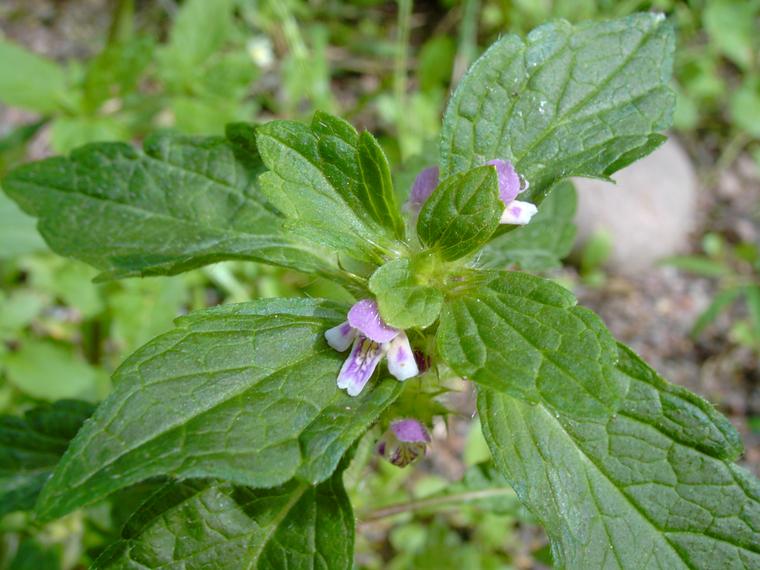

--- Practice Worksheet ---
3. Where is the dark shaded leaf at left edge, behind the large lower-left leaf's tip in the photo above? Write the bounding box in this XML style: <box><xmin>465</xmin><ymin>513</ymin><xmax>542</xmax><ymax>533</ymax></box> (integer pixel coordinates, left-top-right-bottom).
<box><xmin>0</xmin><ymin>400</ymin><xmax>94</xmax><ymax>517</ymax></box>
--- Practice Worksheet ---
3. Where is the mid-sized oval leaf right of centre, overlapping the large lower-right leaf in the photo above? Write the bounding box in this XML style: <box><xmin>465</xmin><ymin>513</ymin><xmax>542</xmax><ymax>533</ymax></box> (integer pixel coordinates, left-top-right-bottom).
<box><xmin>437</xmin><ymin>272</ymin><xmax>625</xmax><ymax>417</ymax></box>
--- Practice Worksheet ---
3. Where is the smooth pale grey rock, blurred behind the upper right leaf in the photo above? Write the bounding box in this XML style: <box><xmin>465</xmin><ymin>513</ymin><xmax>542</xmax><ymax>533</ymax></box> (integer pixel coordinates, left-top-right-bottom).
<box><xmin>574</xmin><ymin>138</ymin><xmax>697</xmax><ymax>274</ymax></box>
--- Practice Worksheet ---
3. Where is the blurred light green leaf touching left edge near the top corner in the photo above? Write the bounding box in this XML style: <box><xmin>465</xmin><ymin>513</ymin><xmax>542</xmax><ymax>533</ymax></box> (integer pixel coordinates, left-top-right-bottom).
<box><xmin>0</xmin><ymin>39</ymin><xmax>66</xmax><ymax>113</ymax></box>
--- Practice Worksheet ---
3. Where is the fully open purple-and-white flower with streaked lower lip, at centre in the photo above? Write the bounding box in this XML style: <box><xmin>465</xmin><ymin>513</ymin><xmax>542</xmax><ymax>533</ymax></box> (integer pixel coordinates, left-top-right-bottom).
<box><xmin>325</xmin><ymin>299</ymin><xmax>419</xmax><ymax>396</ymax></box>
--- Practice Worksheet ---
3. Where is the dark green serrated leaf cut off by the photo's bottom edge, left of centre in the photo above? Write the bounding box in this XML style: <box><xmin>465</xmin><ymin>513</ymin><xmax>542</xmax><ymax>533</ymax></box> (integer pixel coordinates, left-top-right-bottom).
<box><xmin>93</xmin><ymin>472</ymin><xmax>354</xmax><ymax>570</ymax></box>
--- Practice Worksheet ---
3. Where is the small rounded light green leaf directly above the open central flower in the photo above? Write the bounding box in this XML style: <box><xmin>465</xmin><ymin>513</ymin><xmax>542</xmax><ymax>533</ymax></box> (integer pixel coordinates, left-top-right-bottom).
<box><xmin>369</xmin><ymin>258</ymin><xmax>443</xmax><ymax>329</ymax></box>
